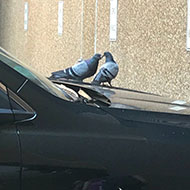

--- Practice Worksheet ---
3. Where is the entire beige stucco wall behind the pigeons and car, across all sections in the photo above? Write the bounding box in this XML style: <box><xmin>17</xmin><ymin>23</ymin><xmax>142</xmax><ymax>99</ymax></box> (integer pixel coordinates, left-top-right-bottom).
<box><xmin>0</xmin><ymin>0</ymin><xmax>190</xmax><ymax>100</ymax></box>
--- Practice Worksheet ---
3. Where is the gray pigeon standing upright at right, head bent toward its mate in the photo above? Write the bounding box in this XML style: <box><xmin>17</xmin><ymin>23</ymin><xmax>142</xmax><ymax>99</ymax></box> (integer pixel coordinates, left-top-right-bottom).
<box><xmin>92</xmin><ymin>52</ymin><xmax>119</xmax><ymax>86</ymax></box>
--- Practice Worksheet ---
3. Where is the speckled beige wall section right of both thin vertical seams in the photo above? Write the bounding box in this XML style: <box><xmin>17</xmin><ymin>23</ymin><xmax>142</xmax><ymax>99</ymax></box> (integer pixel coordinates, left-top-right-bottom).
<box><xmin>97</xmin><ymin>0</ymin><xmax>190</xmax><ymax>100</ymax></box>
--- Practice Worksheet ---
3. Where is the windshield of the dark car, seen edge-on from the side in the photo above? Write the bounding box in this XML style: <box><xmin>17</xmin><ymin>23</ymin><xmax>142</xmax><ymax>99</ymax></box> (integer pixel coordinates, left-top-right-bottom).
<box><xmin>0</xmin><ymin>47</ymin><xmax>69</xmax><ymax>100</ymax></box>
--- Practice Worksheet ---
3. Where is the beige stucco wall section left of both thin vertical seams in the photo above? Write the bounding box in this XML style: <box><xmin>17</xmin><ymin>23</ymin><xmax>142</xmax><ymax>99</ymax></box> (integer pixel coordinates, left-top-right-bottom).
<box><xmin>0</xmin><ymin>0</ymin><xmax>81</xmax><ymax>76</ymax></box>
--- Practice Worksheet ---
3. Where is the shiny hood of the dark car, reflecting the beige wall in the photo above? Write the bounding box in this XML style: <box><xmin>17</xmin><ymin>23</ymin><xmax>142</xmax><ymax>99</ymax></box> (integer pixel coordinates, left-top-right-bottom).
<box><xmin>55</xmin><ymin>81</ymin><xmax>190</xmax><ymax>115</ymax></box>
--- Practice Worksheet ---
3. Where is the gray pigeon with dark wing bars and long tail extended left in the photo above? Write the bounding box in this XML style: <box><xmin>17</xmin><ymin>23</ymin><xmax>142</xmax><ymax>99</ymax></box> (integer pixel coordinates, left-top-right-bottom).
<box><xmin>49</xmin><ymin>54</ymin><xmax>102</xmax><ymax>81</ymax></box>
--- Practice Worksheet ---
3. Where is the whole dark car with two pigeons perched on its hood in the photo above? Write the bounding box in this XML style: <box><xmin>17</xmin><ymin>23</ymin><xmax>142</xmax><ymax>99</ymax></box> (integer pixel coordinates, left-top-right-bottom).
<box><xmin>0</xmin><ymin>48</ymin><xmax>190</xmax><ymax>190</ymax></box>
